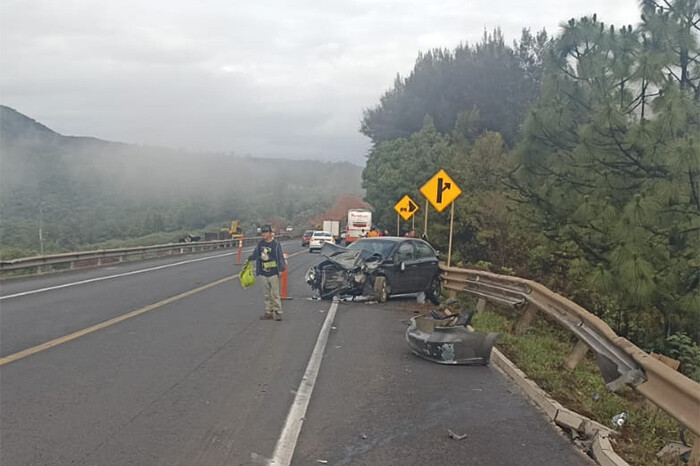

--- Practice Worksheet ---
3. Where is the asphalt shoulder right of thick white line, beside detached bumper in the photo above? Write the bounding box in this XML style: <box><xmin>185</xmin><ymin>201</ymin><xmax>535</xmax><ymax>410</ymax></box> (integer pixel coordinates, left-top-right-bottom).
<box><xmin>292</xmin><ymin>299</ymin><xmax>595</xmax><ymax>466</ymax></box>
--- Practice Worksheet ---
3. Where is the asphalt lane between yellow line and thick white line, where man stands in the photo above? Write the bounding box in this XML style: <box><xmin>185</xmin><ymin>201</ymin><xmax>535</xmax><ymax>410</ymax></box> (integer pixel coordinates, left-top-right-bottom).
<box><xmin>0</xmin><ymin>246</ymin><xmax>329</xmax><ymax>465</ymax></box>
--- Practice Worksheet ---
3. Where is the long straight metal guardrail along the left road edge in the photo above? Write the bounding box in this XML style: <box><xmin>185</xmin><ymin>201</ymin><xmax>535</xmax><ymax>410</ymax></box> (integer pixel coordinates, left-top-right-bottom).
<box><xmin>0</xmin><ymin>236</ymin><xmax>284</xmax><ymax>275</ymax></box>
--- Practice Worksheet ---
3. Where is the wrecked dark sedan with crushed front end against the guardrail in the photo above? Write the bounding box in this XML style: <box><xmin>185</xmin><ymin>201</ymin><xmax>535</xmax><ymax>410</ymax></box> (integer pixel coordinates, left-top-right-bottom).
<box><xmin>306</xmin><ymin>237</ymin><xmax>441</xmax><ymax>304</ymax></box>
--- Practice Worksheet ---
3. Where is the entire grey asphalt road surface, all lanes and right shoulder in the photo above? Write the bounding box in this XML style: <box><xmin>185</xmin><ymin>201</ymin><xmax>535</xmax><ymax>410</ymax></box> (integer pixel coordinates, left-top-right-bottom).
<box><xmin>0</xmin><ymin>243</ymin><xmax>592</xmax><ymax>466</ymax></box>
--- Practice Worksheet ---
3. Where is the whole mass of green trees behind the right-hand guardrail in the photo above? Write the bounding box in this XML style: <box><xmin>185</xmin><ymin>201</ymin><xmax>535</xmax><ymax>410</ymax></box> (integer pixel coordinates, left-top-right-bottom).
<box><xmin>362</xmin><ymin>0</ymin><xmax>700</xmax><ymax>370</ymax></box>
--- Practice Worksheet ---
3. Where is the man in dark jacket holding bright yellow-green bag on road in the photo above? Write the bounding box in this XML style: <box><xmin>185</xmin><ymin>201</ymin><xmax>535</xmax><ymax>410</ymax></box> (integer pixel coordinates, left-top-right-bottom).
<box><xmin>248</xmin><ymin>225</ymin><xmax>287</xmax><ymax>320</ymax></box>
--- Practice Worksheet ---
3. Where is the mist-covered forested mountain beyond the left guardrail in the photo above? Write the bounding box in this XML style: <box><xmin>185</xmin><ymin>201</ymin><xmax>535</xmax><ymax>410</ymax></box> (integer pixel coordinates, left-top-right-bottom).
<box><xmin>0</xmin><ymin>106</ymin><xmax>363</xmax><ymax>255</ymax></box>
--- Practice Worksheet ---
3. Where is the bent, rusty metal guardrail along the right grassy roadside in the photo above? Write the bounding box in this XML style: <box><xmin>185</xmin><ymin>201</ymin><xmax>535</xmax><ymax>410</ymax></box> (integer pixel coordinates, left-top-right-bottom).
<box><xmin>440</xmin><ymin>264</ymin><xmax>700</xmax><ymax>436</ymax></box>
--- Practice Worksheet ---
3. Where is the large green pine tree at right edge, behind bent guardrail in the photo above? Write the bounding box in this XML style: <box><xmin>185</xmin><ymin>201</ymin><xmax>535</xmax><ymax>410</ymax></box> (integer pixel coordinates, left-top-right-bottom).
<box><xmin>511</xmin><ymin>8</ymin><xmax>700</xmax><ymax>346</ymax></box>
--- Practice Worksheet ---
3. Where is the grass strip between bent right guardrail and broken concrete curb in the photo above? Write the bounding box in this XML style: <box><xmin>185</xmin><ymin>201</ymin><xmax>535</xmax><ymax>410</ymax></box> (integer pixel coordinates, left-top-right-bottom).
<box><xmin>471</xmin><ymin>303</ymin><xmax>684</xmax><ymax>466</ymax></box>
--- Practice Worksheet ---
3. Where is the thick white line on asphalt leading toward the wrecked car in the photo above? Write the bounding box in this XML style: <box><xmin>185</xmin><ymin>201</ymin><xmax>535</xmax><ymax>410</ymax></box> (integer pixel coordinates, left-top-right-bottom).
<box><xmin>270</xmin><ymin>301</ymin><xmax>338</xmax><ymax>466</ymax></box>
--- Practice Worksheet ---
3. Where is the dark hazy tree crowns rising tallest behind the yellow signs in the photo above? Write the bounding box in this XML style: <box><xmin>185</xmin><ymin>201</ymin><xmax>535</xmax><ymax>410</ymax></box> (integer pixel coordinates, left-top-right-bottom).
<box><xmin>361</xmin><ymin>29</ymin><xmax>548</xmax><ymax>143</ymax></box>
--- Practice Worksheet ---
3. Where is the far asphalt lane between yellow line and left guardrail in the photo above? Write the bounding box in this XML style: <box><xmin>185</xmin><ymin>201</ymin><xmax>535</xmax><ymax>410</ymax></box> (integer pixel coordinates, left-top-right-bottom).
<box><xmin>0</xmin><ymin>241</ymin><xmax>301</xmax><ymax>357</ymax></box>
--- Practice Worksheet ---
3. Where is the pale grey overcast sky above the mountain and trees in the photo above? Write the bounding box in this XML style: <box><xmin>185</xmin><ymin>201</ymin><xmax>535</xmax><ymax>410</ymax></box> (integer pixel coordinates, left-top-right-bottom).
<box><xmin>0</xmin><ymin>0</ymin><xmax>639</xmax><ymax>164</ymax></box>
